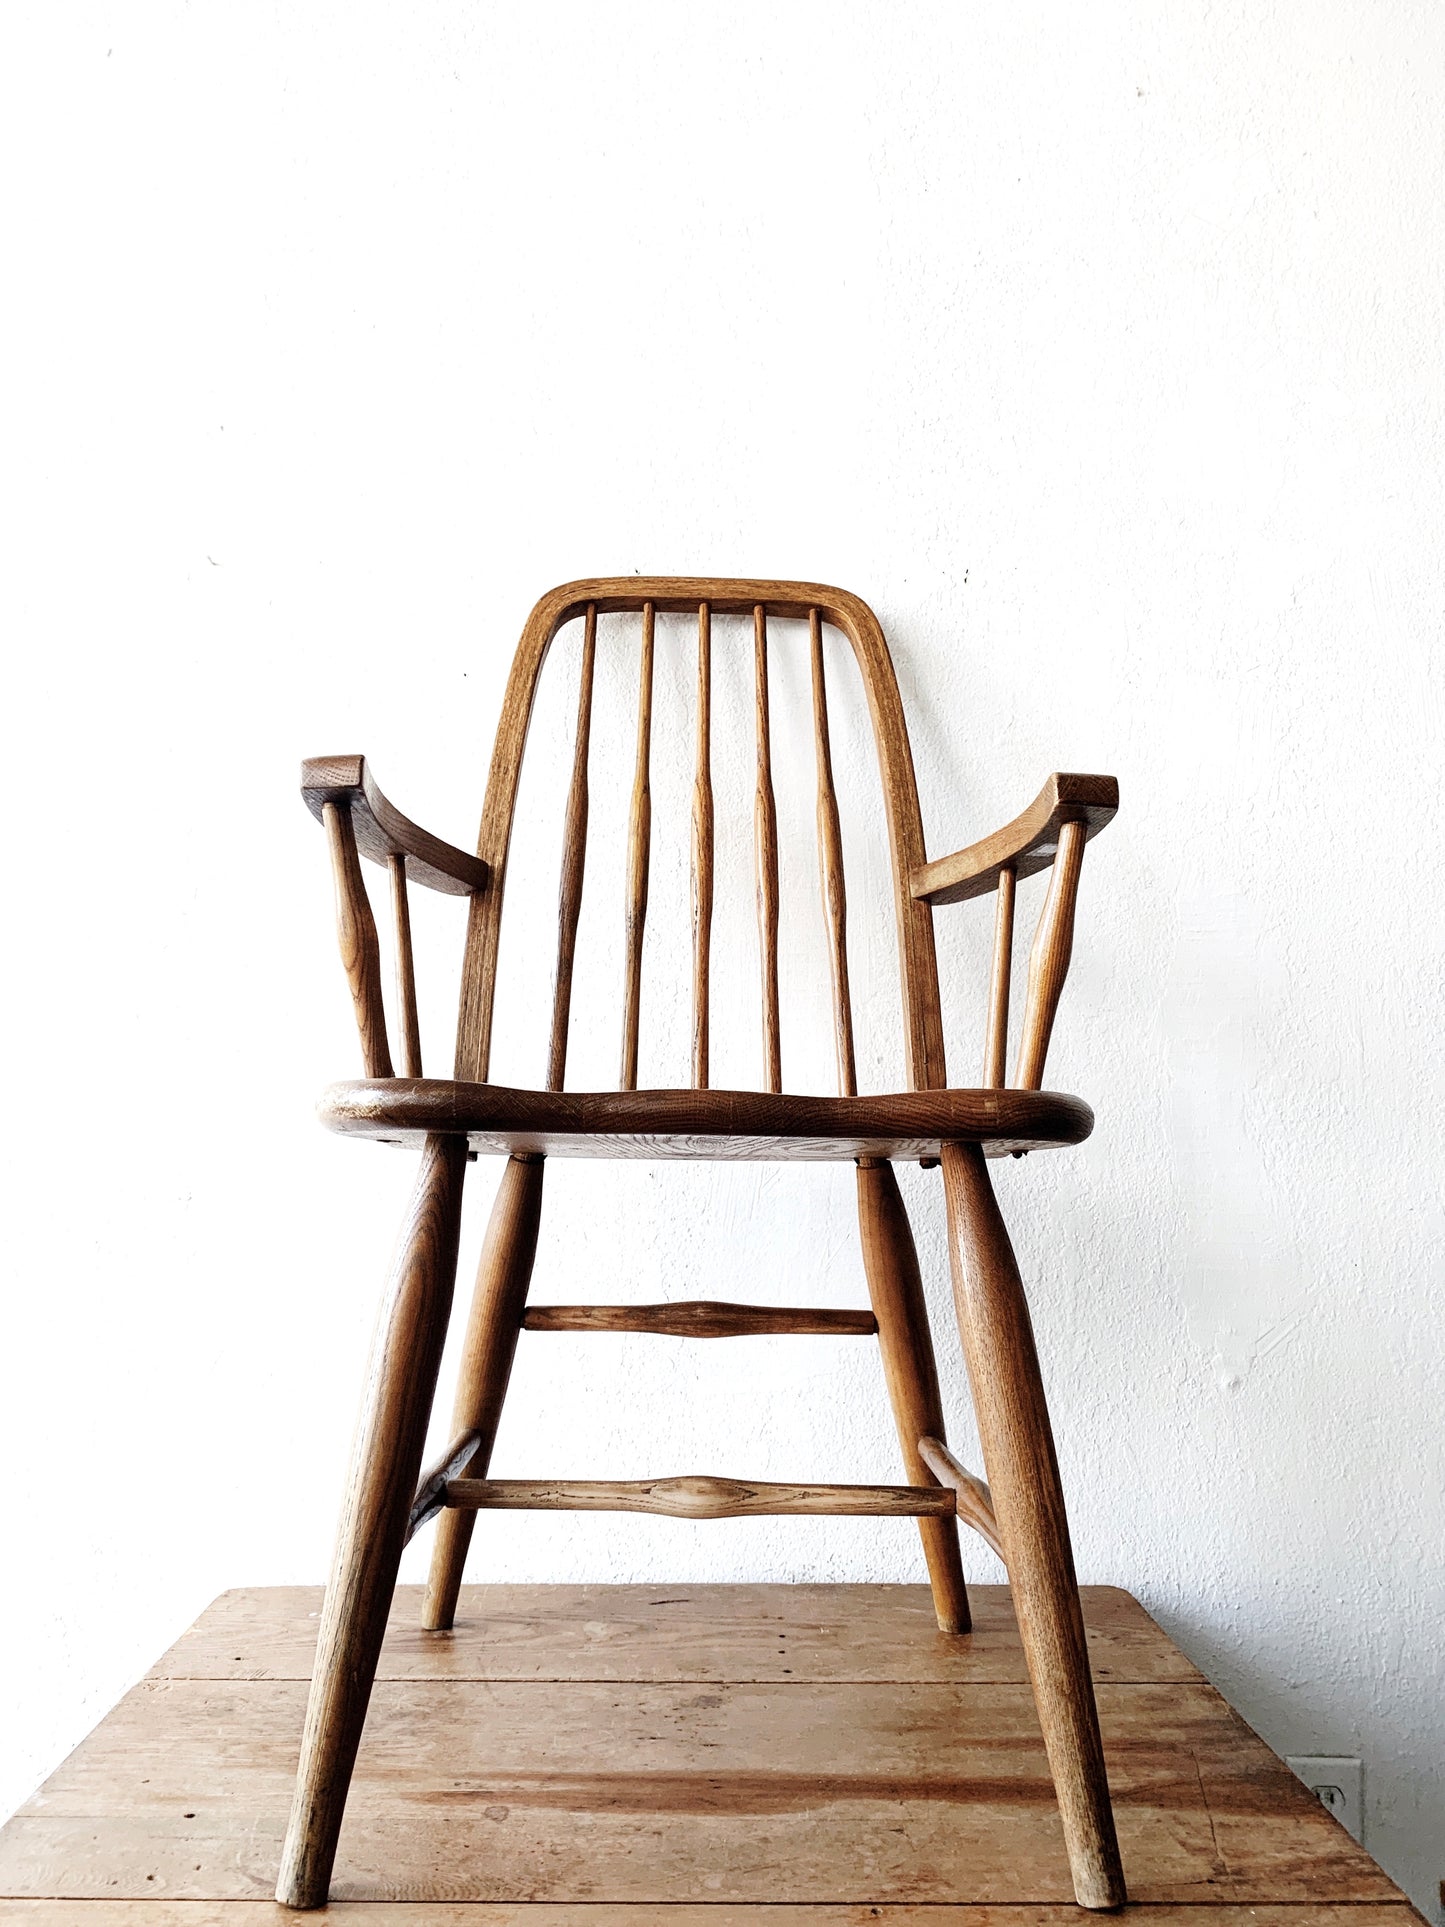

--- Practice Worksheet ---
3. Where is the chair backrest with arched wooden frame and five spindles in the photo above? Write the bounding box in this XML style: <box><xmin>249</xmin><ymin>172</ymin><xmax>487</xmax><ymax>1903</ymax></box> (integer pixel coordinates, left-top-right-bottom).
<box><xmin>457</xmin><ymin>576</ymin><xmax>946</xmax><ymax>1095</ymax></box>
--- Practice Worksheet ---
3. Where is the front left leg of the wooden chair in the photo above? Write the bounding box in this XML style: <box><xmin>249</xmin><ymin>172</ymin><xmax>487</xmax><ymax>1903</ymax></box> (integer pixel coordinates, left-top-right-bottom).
<box><xmin>276</xmin><ymin>1137</ymin><xmax>466</xmax><ymax>1908</ymax></box>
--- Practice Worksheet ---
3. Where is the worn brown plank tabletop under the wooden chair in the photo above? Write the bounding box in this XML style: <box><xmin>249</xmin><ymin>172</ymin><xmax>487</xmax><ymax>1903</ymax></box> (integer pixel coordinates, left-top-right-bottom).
<box><xmin>0</xmin><ymin>1587</ymin><xmax>1418</xmax><ymax>1927</ymax></box>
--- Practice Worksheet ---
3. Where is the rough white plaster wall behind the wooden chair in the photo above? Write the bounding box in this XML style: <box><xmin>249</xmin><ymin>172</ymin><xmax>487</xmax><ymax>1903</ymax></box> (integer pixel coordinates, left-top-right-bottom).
<box><xmin>0</xmin><ymin>0</ymin><xmax>1445</xmax><ymax>1906</ymax></box>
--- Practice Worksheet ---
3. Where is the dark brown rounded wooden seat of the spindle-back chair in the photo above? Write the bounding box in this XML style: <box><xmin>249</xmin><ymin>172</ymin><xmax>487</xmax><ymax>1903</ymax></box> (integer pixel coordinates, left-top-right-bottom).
<box><xmin>320</xmin><ymin>1077</ymin><xmax>1094</xmax><ymax>1162</ymax></box>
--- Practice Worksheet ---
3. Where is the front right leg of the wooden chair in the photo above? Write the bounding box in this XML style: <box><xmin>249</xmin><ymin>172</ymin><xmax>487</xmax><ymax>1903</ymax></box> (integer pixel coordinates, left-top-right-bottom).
<box><xmin>942</xmin><ymin>1145</ymin><xmax>1125</xmax><ymax>1908</ymax></box>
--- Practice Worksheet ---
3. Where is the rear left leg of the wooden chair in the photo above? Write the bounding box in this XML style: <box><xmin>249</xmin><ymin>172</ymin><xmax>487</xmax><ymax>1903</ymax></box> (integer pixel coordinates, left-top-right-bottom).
<box><xmin>422</xmin><ymin>1156</ymin><xmax>545</xmax><ymax>1632</ymax></box>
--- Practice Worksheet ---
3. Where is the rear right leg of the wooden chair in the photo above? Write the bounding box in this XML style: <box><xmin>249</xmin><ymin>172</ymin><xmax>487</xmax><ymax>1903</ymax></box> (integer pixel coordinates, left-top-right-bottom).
<box><xmin>857</xmin><ymin>1158</ymin><xmax>973</xmax><ymax>1632</ymax></box>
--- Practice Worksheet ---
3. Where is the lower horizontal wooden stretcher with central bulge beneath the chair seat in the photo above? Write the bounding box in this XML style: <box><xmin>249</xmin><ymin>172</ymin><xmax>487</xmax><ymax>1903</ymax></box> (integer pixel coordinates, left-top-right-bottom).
<box><xmin>447</xmin><ymin>1472</ymin><xmax>954</xmax><ymax>1518</ymax></box>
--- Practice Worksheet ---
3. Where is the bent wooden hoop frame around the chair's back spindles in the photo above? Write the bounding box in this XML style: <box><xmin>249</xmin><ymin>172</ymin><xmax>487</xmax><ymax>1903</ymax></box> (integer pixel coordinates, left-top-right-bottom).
<box><xmin>455</xmin><ymin>576</ymin><xmax>948</xmax><ymax>1089</ymax></box>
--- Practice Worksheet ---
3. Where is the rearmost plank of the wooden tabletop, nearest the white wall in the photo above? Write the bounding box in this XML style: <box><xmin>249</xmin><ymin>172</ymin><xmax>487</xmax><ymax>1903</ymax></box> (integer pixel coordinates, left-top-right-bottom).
<box><xmin>150</xmin><ymin>1582</ymin><xmax>1204</xmax><ymax>1688</ymax></box>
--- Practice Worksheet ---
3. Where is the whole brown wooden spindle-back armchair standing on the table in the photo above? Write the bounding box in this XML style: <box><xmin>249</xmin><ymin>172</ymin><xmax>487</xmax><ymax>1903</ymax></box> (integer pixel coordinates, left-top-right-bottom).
<box><xmin>277</xmin><ymin>578</ymin><xmax>1125</xmax><ymax>1908</ymax></box>
